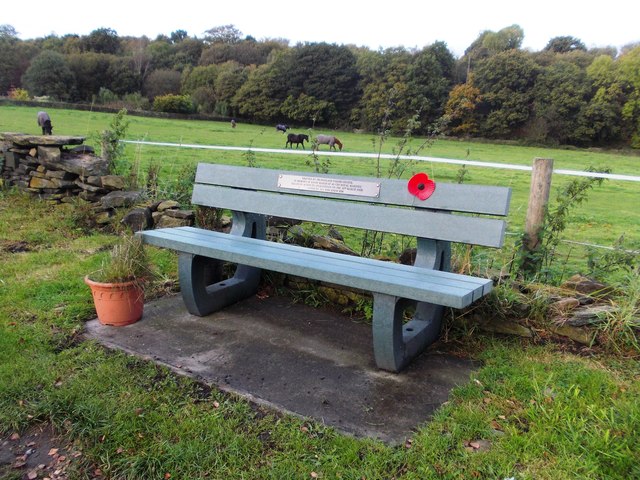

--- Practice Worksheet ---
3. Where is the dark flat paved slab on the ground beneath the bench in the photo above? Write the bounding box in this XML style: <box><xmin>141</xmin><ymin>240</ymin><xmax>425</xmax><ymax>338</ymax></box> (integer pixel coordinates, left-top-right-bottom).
<box><xmin>86</xmin><ymin>296</ymin><xmax>474</xmax><ymax>443</ymax></box>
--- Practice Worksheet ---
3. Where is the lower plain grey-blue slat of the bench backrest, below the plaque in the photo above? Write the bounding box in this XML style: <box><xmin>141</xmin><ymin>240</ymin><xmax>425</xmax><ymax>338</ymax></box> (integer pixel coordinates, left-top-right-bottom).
<box><xmin>193</xmin><ymin>185</ymin><xmax>505</xmax><ymax>247</ymax></box>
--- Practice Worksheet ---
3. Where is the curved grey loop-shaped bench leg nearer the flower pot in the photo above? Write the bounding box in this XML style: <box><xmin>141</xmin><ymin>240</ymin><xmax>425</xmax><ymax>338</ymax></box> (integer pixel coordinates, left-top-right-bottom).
<box><xmin>178</xmin><ymin>212</ymin><xmax>265</xmax><ymax>316</ymax></box>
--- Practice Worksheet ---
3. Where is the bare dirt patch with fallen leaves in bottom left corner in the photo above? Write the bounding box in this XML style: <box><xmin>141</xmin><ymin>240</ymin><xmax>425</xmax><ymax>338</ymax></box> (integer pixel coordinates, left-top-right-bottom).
<box><xmin>0</xmin><ymin>424</ymin><xmax>102</xmax><ymax>480</ymax></box>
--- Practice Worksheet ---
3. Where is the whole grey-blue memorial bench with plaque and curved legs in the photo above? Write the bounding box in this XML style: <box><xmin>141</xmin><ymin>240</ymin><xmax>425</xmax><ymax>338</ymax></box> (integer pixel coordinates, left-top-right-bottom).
<box><xmin>139</xmin><ymin>163</ymin><xmax>511</xmax><ymax>372</ymax></box>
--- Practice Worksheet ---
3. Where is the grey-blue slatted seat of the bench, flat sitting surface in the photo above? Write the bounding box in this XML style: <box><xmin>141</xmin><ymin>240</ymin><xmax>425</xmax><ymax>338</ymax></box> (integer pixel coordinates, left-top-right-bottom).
<box><xmin>142</xmin><ymin>227</ymin><xmax>491</xmax><ymax>308</ymax></box>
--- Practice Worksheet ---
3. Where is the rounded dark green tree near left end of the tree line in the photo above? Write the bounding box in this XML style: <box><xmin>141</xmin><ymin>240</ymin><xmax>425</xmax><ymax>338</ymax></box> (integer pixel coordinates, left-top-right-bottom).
<box><xmin>22</xmin><ymin>50</ymin><xmax>75</xmax><ymax>100</ymax></box>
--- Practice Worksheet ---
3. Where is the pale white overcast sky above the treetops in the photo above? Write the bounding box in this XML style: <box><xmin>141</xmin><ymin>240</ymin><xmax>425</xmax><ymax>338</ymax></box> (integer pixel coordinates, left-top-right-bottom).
<box><xmin>6</xmin><ymin>0</ymin><xmax>640</xmax><ymax>56</ymax></box>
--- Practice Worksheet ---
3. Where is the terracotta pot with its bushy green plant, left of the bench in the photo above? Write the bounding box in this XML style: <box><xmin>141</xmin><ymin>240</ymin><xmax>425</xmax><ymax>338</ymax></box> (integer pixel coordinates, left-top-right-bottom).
<box><xmin>84</xmin><ymin>235</ymin><xmax>153</xmax><ymax>326</ymax></box>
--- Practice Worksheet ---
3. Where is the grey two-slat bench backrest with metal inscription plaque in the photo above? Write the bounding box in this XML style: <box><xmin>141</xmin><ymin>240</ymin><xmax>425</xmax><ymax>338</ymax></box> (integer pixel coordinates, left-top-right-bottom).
<box><xmin>192</xmin><ymin>163</ymin><xmax>511</xmax><ymax>247</ymax></box>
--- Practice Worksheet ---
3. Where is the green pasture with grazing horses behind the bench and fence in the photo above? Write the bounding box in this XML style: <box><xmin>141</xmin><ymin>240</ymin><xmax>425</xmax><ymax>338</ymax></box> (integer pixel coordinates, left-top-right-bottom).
<box><xmin>0</xmin><ymin>105</ymin><xmax>640</xmax><ymax>282</ymax></box>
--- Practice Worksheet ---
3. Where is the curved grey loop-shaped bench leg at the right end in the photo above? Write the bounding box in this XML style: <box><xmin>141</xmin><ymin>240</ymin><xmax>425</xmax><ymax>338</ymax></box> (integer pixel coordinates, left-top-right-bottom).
<box><xmin>373</xmin><ymin>239</ymin><xmax>451</xmax><ymax>372</ymax></box>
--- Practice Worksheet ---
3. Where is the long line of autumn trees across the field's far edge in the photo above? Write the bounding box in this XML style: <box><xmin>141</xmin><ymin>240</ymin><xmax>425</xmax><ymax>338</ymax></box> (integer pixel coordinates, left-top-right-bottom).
<box><xmin>0</xmin><ymin>25</ymin><xmax>640</xmax><ymax>148</ymax></box>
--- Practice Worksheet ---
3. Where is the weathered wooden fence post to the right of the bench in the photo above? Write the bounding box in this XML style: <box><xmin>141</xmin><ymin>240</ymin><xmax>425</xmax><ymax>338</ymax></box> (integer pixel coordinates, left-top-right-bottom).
<box><xmin>522</xmin><ymin>158</ymin><xmax>553</xmax><ymax>273</ymax></box>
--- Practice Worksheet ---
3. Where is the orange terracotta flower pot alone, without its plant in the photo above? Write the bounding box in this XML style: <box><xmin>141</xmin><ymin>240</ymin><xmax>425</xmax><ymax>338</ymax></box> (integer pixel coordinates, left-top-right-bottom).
<box><xmin>84</xmin><ymin>276</ymin><xmax>144</xmax><ymax>327</ymax></box>
